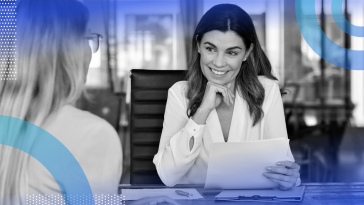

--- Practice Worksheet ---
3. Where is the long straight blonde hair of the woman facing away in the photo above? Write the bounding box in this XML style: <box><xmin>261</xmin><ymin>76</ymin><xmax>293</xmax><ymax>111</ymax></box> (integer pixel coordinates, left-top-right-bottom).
<box><xmin>0</xmin><ymin>0</ymin><xmax>88</xmax><ymax>204</ymax></box>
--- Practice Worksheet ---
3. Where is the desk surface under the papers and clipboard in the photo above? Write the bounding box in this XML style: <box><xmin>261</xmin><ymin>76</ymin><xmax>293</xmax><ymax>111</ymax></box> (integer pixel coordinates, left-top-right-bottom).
<box><xmin>120</xmin><ymin>183</ymin><xmax>364</xmax><ymax>205</ymax></box>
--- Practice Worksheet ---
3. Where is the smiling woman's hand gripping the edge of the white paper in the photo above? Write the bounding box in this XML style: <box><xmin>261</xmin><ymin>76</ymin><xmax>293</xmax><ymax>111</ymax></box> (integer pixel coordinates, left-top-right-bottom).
<box><xmin>263</xmin><ymin>161</ymin><xmax>300</xmax><ymax>190</ymax></box>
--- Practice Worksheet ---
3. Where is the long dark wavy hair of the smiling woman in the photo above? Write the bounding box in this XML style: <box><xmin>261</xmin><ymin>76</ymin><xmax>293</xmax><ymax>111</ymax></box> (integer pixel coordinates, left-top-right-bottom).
<box><xmin>186</xmin><ymin>4</ymin><xmax>277</xmax><ymax>126</ymax></box>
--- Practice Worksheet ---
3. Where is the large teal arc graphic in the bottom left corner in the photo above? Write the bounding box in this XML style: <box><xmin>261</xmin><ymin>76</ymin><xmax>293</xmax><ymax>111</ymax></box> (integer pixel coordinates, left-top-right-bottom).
<box><xmin>0</xmin><ymin>115</ymin><xmax>95</xmax><ymax>205</ymax></box>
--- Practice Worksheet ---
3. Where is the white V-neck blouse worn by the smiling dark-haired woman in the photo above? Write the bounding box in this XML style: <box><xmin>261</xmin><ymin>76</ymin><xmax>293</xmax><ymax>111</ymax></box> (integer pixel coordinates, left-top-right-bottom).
<box><xmin>153</xmin><ymin>77</ymin><xmax>300</xmax><ymax>186</ymax></box>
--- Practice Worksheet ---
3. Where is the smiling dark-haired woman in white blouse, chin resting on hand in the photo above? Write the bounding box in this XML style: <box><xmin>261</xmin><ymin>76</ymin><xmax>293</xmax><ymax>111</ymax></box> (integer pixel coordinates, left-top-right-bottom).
<box><xmin>154</xmin><ymin>4</ymin><xmax>300</xmax><ymax>189</ymax></box>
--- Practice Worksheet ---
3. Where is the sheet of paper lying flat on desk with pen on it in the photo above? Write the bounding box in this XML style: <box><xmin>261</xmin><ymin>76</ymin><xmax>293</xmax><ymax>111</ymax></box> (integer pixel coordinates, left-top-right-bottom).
<box><xmin>121</xmin><ymin>188</ymin><xmax>203</xmax><ymax>200</ymax></box>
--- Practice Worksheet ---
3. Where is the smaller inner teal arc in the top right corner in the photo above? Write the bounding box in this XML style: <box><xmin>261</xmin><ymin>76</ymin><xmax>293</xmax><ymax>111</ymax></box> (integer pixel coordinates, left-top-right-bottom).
<box><xmin>331</xmin><ymin>0</ymin><xmax>364</xmax><ymax>37</ymax></box>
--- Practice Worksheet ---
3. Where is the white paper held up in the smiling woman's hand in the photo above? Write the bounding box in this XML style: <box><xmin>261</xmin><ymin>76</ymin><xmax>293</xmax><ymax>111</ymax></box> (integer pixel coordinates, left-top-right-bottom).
<box><xmin>205</xmin><ymin>138</ymin><xmax>290</xmax><ymax>189</ymax></box>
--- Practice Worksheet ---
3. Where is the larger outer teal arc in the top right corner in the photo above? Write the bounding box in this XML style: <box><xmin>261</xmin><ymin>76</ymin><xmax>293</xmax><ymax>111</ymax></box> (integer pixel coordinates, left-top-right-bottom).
<box><xmin>295</xmin><ymin>0</ymin><xmax>364</xmax><ymax>70</ymax></box>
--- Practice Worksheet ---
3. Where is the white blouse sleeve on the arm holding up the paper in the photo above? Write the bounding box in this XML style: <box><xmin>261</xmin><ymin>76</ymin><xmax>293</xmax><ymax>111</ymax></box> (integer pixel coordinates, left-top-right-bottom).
<box><xmin>264</xmin><ymin>82</ymin><xmax>301</xmax><ymax>186</ymax></box>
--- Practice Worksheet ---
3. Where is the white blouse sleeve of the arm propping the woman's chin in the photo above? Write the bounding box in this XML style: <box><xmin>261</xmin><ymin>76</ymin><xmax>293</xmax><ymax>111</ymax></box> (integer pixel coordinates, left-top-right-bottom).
<box><xmin>153</xmin><ymin>84</ymin><xmax>205</xmax><ymax>186</ymax></box>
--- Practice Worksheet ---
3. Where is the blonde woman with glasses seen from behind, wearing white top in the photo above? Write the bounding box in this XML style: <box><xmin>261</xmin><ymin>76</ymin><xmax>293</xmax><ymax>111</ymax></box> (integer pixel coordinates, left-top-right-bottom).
<box><xmin>0</xmin><ymin>0</ymin><xmax>175</xmax><ymax>205</ymax></box>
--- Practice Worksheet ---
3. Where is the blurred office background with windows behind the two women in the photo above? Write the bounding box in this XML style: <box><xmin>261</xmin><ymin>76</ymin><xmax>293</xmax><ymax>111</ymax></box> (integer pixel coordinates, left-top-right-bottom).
<box><xmin>77</xmin><ymin>0</ymin><xmax>364</xmax><ymax>183</ymax></box>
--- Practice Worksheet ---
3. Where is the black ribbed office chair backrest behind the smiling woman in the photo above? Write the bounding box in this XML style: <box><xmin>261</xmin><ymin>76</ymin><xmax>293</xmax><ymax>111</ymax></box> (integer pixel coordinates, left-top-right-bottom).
<box><xmin>130</xmin><ymin>69</ymin><xmax>186</xmax><ymax>184</ymax></box>
